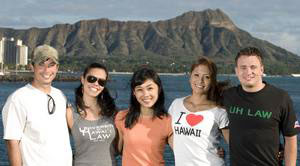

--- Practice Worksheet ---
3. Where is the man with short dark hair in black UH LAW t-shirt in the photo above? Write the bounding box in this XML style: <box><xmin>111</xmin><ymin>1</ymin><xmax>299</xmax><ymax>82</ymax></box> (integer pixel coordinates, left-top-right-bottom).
<box><xmin>224</xmin><ymin>47</ymin><xmax>298</xmax><ymax>166</ymax></box>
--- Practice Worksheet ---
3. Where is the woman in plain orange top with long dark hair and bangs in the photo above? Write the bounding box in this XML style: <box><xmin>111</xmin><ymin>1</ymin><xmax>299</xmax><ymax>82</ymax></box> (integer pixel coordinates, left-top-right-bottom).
<box><xmin>115</xmin><ymin>68</ymin><xmax>172</xmax><ymax>166</ymax></box>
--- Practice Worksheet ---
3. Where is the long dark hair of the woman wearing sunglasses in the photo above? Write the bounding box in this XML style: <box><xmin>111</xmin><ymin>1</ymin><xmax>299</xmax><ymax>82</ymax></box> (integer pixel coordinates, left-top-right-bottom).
<box><xmin>75</xmin><ymin>63</ymin><xmax>116</xmax><ymax>117</ymax></box>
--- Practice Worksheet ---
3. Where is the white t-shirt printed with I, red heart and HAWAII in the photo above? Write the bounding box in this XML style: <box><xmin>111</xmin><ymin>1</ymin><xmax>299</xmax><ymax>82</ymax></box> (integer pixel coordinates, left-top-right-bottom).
<box><xmin>169</xmin><ymin>97</ymin><xmax>229</xmax><ymax>166</ymax></box>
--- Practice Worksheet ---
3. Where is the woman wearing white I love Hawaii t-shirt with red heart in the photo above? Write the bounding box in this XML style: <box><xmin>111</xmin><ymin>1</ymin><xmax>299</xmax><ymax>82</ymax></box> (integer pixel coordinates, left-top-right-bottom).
<box><xmin>169</xmin><ymin>58</ymin><xmax>229</xmax><ymax>166</ymax></box>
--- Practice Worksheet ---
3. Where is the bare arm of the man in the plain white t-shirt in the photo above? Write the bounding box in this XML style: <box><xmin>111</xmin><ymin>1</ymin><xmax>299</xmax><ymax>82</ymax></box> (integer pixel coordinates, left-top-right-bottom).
<box><xmin>5</xmin><ymin>140</ymin><xmax>22</xmax><ymax>166</ymax></box>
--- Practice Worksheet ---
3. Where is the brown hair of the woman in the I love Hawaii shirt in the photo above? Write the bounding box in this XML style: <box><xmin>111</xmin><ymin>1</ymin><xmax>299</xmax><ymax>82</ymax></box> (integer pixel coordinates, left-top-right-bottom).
<box><xmin>191</xmin><ymin>57</ymin><xmax>229</xmax><ymax>106</ymax></box>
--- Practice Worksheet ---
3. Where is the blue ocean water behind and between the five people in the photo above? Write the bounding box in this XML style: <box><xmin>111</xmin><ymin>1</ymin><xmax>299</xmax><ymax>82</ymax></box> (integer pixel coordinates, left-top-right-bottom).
<box><xmin>0</xmin><ymin>75</ymin><xmax>300</xmax><ymax>166</ymax></box>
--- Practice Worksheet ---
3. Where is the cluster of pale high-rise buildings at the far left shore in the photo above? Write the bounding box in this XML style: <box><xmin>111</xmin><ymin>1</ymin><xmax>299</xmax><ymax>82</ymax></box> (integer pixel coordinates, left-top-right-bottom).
<box><xmin>0</xmin><ymin>37</ymin><xmax>28</xmax><ymax>65</ymax></box>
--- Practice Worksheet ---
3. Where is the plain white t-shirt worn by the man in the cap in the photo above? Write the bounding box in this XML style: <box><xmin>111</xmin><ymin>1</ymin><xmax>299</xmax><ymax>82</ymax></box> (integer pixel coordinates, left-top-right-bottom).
<box><xmin>2</xmin><ymin>84</ymin><xmax>72</xmax><ymax>166</ymax></box>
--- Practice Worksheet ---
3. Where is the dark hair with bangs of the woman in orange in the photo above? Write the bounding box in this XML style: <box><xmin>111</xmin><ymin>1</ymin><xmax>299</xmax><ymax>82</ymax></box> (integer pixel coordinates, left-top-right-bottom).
<box><xmin>125</xmin><ymin>67</ymin><xmax>168</xmax><ymax>128</ymax></box>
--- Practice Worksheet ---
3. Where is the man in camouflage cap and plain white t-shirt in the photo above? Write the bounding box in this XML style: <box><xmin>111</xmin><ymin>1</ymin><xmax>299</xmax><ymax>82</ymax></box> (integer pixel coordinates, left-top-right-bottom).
<box><xmin>2</xmin><ymin>45</ymin><xmax>72</xmax><ymax>166</ymax></box>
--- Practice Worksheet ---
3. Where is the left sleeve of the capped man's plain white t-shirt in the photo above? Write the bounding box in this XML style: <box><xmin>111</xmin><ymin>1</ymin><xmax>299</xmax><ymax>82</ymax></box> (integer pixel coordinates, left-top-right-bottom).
<box><xmin>2</xmin><ymin>95</ymin><xmax>26</xmax><ymax>140</ymax></box>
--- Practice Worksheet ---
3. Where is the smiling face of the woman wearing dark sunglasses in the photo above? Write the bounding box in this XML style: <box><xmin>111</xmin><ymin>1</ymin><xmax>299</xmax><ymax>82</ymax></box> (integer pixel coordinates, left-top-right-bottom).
<box><xmin>81</xmin><ymin>68</ymin><xmax>107</xmax><ymax>97</ymax></box>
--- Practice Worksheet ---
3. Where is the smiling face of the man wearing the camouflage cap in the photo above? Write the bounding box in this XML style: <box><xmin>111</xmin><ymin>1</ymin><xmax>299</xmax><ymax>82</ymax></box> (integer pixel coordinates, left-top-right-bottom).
<box><xmin>31</xmin><ymin>59</ymin><xmax>58</xmax><ymax>88</ymax></box>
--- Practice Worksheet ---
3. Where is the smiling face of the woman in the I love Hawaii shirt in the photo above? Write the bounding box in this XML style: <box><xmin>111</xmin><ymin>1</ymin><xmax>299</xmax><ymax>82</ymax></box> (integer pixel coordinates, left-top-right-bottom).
<box><xmin>190</xmin><ymin>65</ymin><xmax>211</xmax><ymax>94</ymax></box>
